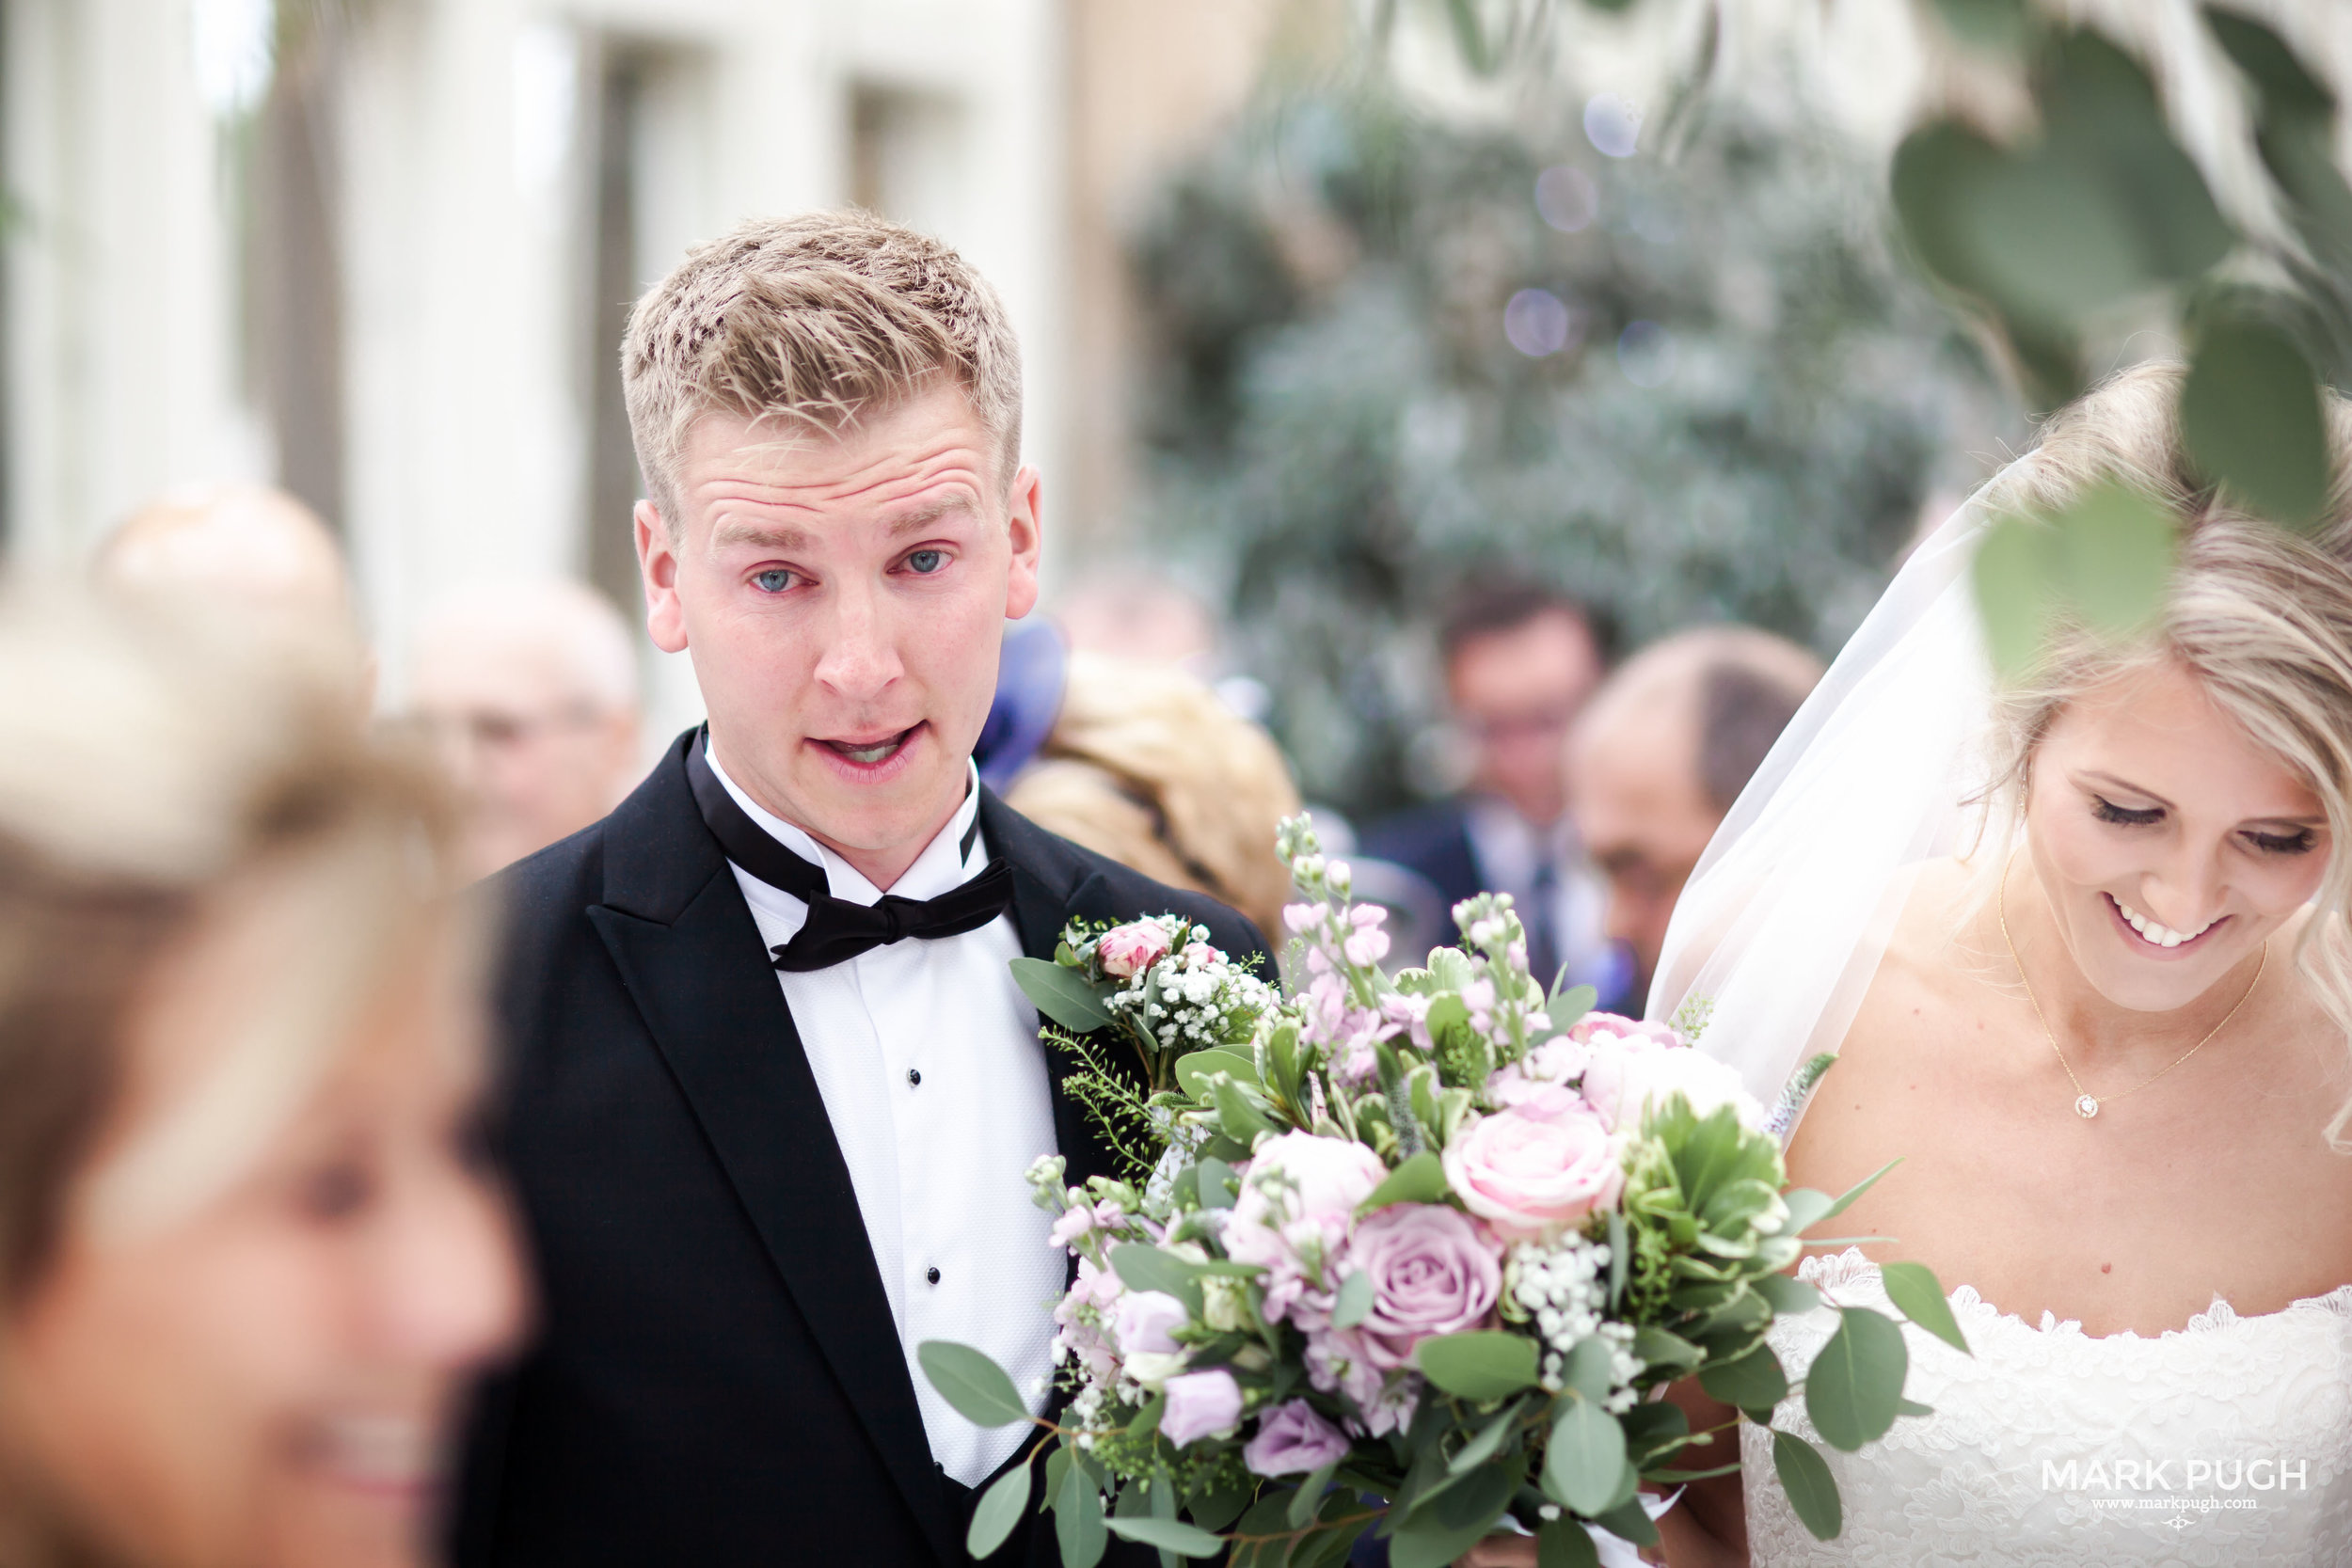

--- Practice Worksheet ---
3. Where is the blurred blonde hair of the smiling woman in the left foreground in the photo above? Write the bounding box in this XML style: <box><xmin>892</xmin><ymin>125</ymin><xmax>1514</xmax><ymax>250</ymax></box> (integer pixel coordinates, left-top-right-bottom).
<box><xmin>0</xmin><ymin>583</ymin><xmax>447</xmax><ymax>1300</ymax></box>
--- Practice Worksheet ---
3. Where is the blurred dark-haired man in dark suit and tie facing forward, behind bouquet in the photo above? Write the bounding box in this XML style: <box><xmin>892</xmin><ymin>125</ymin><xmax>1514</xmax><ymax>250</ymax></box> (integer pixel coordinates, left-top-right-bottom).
<box><xmin>1359</xmin><ymin>578</ymin><xmax>1626</xmax><ymax>1004</ymax></box>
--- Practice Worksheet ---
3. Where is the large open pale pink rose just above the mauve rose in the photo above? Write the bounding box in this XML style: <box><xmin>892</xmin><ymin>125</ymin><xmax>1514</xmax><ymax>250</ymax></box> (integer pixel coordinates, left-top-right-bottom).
<box><xmin>1444</xmin><ymin>1084</ymin><xmax>1626</xmax><ymax>1242</ymax></box>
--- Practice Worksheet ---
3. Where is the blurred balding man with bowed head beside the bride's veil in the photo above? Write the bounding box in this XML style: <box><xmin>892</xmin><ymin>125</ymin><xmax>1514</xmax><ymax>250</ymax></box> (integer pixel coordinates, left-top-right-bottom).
<box><xmin>1569</xmin><ymin>626</ymin><xmax>1820</xmax><ymax>1006</ymax></box>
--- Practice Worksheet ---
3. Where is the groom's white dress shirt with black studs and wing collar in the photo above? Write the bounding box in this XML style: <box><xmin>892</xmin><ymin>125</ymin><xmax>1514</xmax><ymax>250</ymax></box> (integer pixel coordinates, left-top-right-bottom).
<box><xmin>710</xmin><ymin>757</ymin><xmax>1066</xmax><ymax>1486</ymax></box>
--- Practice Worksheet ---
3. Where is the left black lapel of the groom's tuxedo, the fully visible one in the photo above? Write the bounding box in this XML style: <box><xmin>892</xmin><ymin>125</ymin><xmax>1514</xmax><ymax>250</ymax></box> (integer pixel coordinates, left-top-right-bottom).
<box><xmin>588</xmin><ymin>731</ymin><xmax>962</xmax><ymax>1561</ymax></box>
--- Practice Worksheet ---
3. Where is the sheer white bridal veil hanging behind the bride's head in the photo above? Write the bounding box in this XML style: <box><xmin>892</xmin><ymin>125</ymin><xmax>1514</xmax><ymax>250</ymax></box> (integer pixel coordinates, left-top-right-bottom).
<box><xmin>1649</xmin><ymin>500</ymin><xmax>1993</xmax><ymax>1128</ymax></box>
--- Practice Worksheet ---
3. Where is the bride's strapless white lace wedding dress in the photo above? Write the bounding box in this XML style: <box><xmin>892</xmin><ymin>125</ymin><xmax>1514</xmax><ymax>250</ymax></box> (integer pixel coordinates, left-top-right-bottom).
<box><xmin>1740</xmin><ymin>1248</ymin><xmax>2352</xmax><ymax>1568</ymax></box>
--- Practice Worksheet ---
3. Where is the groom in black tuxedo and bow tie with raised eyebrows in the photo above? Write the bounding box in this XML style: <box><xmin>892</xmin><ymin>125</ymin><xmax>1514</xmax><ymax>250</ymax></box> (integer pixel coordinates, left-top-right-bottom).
<box><xmin>452</xmin><ymin>214</ymin><xmax>1265</xmax><ymax>1568</ymax></box>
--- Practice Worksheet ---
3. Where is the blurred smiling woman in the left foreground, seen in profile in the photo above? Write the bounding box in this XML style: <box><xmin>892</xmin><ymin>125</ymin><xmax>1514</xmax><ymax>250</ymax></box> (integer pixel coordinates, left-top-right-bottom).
<box><xmin>0</xmin><ymin>588</ymin><xmax>525</xmax><ymax>1568</ymax></box>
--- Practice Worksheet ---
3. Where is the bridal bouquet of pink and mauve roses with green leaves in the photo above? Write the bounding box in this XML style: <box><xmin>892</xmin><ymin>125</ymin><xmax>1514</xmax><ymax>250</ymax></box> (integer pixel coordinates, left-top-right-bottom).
<box><xmin>917</xmin><ymin>818</ymin><xmax>1960</xmax><ymax>1568</ymax></box>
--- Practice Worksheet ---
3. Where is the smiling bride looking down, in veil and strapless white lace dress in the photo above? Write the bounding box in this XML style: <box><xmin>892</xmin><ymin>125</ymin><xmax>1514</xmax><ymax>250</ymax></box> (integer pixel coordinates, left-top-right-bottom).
<box><xmin>1651</xmin><ymin>367</ymin><xmax>2352</xmax><ymax>1568</ymax></box>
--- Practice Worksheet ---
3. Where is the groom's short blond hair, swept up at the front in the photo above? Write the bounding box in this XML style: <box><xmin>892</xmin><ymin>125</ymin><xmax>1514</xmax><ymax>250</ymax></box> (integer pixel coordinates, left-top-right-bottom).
<box><xmin>621</xmin><ymin>209</ymin><xmax>1021</xmax><ymax>538</ymax></box>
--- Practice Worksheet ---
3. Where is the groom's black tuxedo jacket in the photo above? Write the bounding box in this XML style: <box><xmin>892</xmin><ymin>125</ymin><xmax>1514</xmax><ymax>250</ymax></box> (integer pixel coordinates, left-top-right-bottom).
<box><xmin>452</xmin><ymin>731</ymin><xmax>1270</xmax><ymax>1568</ymax></box>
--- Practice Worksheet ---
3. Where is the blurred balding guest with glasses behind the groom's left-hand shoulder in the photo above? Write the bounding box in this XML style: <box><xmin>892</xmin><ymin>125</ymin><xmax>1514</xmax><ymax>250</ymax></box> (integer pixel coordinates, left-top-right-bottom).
<box><xmin>409</xmin><ymin>578</ymin><xmax>644</xmax><ymax>877</ymax></box>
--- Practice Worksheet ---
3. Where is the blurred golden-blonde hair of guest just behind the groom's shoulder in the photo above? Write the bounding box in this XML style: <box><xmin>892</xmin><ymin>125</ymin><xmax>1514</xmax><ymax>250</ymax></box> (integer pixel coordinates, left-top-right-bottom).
<box><xmin>1005</xmin><ymin>651</ymin><xmax>1298</xmax><ymax>933</ymax></box>
